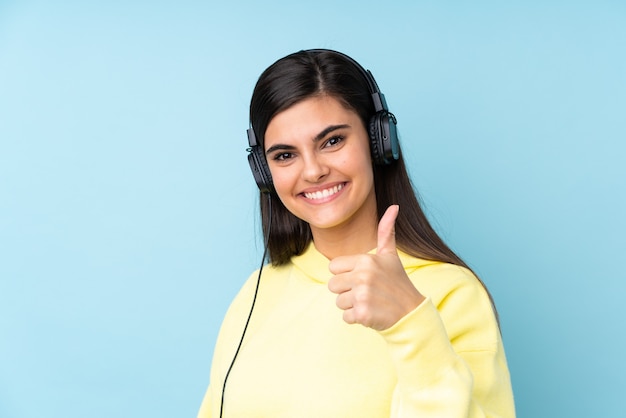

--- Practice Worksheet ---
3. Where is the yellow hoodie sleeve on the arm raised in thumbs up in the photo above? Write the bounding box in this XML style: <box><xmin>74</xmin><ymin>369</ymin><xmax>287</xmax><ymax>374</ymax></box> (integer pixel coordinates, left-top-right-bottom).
<box><xmin>381</xmin><ymin>264</ymin><xmax>515</xmax><ymax>418</ymax></box>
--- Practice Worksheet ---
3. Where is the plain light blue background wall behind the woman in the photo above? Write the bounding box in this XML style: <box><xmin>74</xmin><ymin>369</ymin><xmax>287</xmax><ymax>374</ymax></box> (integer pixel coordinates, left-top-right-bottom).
<box><xmin>0</xmin><ymin>0</ymin><xmax>626</xmax><ymax>418</ymax></box>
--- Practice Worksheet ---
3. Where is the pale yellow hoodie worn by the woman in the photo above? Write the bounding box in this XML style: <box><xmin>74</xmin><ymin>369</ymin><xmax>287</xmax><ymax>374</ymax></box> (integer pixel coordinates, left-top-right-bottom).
<box><xmin>198</xmin><ymin>244</ymin><xmax>515</xmax><ymax>418</ymax></box>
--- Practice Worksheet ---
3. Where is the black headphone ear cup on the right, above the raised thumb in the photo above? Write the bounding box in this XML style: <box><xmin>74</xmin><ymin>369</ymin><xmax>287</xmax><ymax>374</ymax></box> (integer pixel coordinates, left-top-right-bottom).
<box><xmin>369</xmin><ymin>111</ymin><xmax>399</xmax><ymax>165</ymax></box>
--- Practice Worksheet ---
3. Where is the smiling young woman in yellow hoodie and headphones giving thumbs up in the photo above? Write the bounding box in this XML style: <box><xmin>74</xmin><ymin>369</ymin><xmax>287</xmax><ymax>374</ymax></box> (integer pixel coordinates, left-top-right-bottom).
<box><xmin>198</xmin><ymin>50</ymin><xmax>515</xmax><ymax>418</ymax></box>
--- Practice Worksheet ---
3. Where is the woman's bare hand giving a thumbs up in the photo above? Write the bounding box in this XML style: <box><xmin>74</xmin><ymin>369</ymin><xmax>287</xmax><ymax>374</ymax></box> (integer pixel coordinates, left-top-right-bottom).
<box><xmin>328</xmin><ymin>205</ymin><xmax>424</xmax><ymax>331</ymax></box>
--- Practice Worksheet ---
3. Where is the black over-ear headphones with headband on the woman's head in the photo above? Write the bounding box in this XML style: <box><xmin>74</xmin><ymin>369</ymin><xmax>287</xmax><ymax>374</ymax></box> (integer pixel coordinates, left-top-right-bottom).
<box><xmin>247</xmin><ymin>49</ymin><xmax>400</xmax><ymax>193</ymax></box>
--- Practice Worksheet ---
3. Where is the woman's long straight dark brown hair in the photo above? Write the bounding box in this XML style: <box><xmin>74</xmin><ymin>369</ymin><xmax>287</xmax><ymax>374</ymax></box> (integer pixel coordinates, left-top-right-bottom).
<box><xmin>250</xmin><ymin>50</ymin><xmax>497</xmax><ymax>317</ymax></box>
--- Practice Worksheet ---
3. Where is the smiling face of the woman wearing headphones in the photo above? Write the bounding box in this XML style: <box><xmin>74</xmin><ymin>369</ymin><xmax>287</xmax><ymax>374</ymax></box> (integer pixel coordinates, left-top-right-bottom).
<box><xmin>265</xmin><ymin>96</ymin><xmax>377</xmax><ymax>235</ymax></box>
